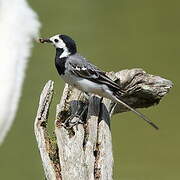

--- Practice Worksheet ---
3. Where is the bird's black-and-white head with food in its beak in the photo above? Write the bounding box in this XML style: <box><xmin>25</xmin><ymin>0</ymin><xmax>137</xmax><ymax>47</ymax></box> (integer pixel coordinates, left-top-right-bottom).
<box><xmin>39</xmin><ymin>34</ymin><xmax>77</xmax><ymax>58</ymax></box>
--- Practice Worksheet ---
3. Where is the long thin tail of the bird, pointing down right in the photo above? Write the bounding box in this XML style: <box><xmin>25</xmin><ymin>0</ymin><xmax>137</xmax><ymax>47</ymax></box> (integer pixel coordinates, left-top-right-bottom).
<box><xmin>114</xmin><ymin>96</ymin><xmax>159</xmax><ymax>130</ymax></box>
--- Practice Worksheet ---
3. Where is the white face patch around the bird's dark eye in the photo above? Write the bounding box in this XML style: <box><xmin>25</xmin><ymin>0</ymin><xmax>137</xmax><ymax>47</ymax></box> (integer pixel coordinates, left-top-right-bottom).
<box><xmin>49</xmin><ymin>35</ymin><xmax>70</xmax><ymax>58</ymax></box>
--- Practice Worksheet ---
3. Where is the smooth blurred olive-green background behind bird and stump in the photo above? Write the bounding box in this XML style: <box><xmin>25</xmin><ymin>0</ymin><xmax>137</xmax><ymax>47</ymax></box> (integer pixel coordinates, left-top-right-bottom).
<box><xmin>0</xmin><ymin>0</ymin><xmax>180</xmax><ymax>180</ymax></box>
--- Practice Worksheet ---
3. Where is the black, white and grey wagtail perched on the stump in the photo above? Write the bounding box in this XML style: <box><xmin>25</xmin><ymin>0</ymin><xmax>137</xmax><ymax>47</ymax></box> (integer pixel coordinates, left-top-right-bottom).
<box><xmin>39</xmin><ymin>35</ymin><xmax>158</xmax><ymax>129</ymax></box>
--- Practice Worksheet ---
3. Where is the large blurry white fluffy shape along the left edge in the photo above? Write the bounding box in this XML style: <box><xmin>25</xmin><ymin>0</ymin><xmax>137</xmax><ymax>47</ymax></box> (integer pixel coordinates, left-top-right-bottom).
<box><xmin>0</xmin><ymin>0</ymin><xmax>40</xmax><ymax>143</ymax></box>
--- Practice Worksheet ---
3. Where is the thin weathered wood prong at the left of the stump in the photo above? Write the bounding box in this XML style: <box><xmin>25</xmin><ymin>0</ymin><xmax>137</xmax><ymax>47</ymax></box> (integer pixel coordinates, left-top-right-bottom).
<box><xmin>34</xmin><ymin>81</ymin><xmax>61</xmax><ymax>180</ymax></box>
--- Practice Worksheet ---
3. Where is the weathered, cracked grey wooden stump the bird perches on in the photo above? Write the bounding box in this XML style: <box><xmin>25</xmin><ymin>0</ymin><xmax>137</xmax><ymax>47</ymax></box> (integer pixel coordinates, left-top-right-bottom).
<box><xmin>34</xmin><ymin>69</ymin><xmax>172</xmax><ymax>180</ymax></box>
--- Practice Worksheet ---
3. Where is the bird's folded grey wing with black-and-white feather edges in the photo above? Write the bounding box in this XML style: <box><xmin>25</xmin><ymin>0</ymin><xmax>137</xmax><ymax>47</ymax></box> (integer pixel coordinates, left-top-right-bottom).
<box><xmin>68</xmin><ymin>55</ymin><xmax>121</xmax><ymax>91</ymax></box>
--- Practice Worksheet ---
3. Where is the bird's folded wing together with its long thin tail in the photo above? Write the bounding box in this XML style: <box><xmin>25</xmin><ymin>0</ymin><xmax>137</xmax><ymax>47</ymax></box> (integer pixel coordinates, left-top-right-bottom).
<box><xmin>66</xmin><ymin>54</ymin><xmax>158</xmax><ymax>129</ymax></box>
